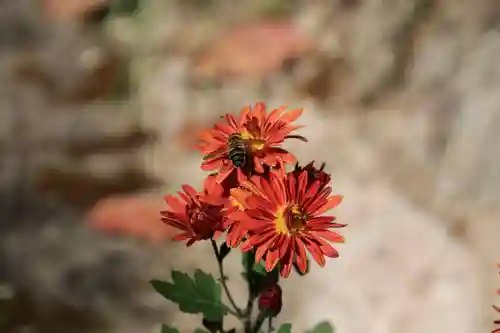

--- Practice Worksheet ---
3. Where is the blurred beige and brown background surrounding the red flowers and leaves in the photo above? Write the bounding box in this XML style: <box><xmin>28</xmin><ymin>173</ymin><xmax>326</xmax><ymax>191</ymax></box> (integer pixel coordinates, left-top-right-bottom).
<box><xmin>0</xmin><ymin>0</ymin><xmax>500</xmax><ymax>333</ymax></box>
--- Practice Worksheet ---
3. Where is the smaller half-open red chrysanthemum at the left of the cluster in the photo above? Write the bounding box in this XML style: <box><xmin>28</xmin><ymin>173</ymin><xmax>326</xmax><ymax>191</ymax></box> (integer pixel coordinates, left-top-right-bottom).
<box><xmin>161</xmin><ymin>176</ymin><xmax>226</xmax><ymax>246</ymax></box>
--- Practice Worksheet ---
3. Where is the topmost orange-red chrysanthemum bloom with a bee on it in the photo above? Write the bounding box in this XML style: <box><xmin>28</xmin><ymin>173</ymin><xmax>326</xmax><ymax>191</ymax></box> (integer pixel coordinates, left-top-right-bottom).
<box><xmin>197</xmin><ymin>103</ymin><xmax>307</xmax><ymax>182</ymax></box>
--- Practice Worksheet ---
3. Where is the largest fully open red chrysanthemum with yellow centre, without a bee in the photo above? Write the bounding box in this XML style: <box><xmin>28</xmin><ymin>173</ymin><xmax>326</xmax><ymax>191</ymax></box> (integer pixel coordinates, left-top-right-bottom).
<box><xmin>229</xmin><ymin>170</ymin><xmax>345</xmax><ymax>277</ymax></box>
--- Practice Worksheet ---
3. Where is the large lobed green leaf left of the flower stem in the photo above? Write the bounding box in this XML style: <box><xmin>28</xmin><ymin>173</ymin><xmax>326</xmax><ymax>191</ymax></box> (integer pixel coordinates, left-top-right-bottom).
<box><xmin>151</xmin><ymin>269</ymin><xmax>227</xmax><ymax>322</ymax></box>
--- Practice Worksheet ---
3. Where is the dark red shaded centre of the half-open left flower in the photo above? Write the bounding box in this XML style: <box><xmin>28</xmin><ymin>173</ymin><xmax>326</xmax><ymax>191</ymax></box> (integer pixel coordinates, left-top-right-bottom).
<box><xmin>188</xmin><ymin>203</ymin><xmax>222</xmax><ymax>239</ymax></box>
